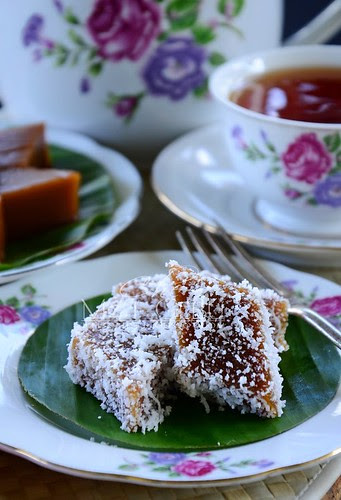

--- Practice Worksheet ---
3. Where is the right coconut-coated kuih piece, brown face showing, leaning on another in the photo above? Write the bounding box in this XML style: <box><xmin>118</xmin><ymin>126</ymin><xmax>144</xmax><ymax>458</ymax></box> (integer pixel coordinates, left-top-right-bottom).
<box><xmin>168</xmin><ymin>261</ymin><xmax>284</xmax><ymax>417</ymax></box>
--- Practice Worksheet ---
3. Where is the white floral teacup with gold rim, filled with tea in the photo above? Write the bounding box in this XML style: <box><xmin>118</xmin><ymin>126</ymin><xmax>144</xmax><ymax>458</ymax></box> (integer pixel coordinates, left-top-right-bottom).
<box><xmin>209</xmin><ymin>45</ymin><xmax>341</xmax><ymax>237</ymax></box>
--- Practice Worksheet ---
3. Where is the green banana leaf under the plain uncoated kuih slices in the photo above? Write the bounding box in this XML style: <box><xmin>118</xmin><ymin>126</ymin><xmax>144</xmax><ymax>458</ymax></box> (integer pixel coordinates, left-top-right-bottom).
<box><xmin>0</xmin><ymin>145</ymin><xmax>116</xmax><ymax>272</ymax></box>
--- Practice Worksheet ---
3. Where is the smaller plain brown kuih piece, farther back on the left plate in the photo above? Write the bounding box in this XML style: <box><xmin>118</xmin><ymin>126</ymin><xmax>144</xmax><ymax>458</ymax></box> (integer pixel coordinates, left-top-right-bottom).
<box><xmin>0</xmin><ymin>123</ymin><xmax>51</xmax><ymax>170</ymax></box>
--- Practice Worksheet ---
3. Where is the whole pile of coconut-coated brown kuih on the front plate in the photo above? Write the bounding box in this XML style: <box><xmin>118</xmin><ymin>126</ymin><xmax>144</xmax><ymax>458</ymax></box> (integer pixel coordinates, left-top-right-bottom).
<box><xmin>65</xmin><ymin>261</ymin><xmax>288</xmax><ymax>433</ymax></box>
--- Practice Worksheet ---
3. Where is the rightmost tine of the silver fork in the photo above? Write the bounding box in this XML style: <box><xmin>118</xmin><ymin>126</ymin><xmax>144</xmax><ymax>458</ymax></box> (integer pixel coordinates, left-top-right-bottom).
<box><xmin>217</xmin><ymin>224</ymin><xmax>290</xmax><ymax>297</ymax></box>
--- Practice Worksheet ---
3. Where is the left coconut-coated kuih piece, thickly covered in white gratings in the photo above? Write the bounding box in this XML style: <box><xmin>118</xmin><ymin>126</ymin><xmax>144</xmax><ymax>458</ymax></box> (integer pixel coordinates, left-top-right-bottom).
<box><xmin>65</xmin><ymin>277</ymin><xmax>173</xmax><ymax>433</ymax></box>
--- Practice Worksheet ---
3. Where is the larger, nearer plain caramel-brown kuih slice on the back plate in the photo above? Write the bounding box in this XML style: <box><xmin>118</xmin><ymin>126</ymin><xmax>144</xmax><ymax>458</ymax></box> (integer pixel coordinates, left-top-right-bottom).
<box><xmin>0</xmin><ymin>167</ymin><xmax>80</xmax><ymax>260</ymax></box>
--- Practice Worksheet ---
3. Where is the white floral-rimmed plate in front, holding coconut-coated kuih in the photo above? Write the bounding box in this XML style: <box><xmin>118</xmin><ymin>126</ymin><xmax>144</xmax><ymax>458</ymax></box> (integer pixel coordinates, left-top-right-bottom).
<box><xmin>0</xmin><ymin>251</ymin><xmax>341</xmax><ymax>486</ymax></box>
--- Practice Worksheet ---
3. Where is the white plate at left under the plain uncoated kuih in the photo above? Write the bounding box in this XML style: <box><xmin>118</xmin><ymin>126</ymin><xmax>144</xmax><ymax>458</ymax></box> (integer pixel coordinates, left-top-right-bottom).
<box><xmin>0</xmin><ymin>129</ymin><xmax>142</xmax><ymax>284</ymax></box>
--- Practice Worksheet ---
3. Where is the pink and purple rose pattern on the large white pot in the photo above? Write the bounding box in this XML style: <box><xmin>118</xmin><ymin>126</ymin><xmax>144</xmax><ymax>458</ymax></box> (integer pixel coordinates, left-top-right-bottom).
<box><xmin>21</xmin><ymin>0</ymin><xmax>245</xmax><ymax>123</ymax></box>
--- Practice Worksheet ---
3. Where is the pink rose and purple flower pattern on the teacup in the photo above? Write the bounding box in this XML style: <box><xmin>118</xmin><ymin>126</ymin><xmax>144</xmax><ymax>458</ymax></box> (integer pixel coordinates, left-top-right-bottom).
<box><xmin>231</xmin><ymin>129</ymin><xmax>341</xmax><ymax>208</ymax></box>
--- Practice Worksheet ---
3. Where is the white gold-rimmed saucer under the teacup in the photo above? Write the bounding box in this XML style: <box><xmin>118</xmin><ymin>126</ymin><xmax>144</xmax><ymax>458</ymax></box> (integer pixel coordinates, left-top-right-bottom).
<box><xmin>152</xmin><ymin>123</ymin><xmax>341</xmax><ymax>267</ymax></box>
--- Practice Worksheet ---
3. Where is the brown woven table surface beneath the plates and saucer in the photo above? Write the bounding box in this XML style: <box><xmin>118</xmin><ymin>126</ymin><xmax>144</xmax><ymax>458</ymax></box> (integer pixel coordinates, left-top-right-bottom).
<box><xmin>0</xmin><ymin>169</ymin><xmax>341</xmax><ymax>500</ymax></box>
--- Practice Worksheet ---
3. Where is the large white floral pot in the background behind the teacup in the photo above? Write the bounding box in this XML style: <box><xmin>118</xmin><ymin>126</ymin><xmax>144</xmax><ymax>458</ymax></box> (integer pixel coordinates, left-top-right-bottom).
<box><xmin>0</xmin><ymin>0</ymin><xmax>340</xmax><ymax>156</ymax></box>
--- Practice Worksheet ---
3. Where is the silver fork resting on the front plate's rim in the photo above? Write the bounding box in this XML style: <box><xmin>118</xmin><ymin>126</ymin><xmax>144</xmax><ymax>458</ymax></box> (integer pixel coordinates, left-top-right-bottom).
<box><xmin>176</xmin><ymin>226</ymin><xmax>341</xmax><ymax>349</ymax></box>
